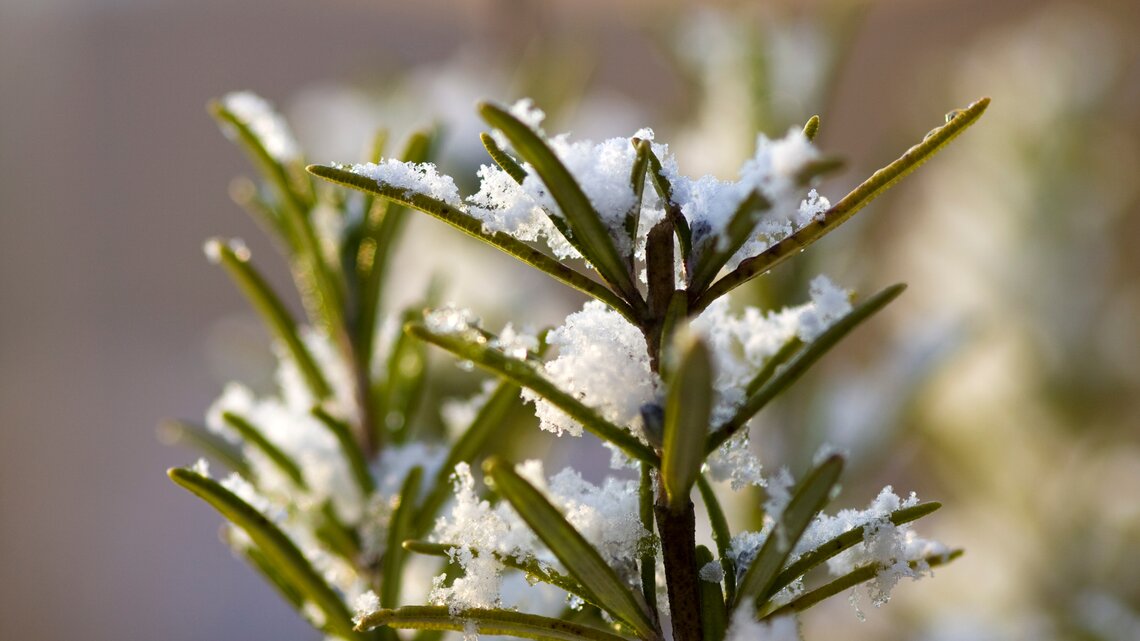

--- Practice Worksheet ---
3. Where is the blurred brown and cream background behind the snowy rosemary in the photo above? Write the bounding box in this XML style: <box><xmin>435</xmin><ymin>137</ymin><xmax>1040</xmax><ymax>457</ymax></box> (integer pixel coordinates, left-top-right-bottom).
<box><xmin>0</xmin><ymin>0</ymin><xmax>1140</xmax><ymax>641</ymax></box>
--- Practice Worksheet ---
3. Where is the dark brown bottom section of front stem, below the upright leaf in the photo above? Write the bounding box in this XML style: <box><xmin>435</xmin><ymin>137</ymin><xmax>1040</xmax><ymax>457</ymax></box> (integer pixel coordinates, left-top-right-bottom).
<box><xmin>653</xmin><ymin>484</ymin><xmax>701</xmax><ymax>641</ymax></box>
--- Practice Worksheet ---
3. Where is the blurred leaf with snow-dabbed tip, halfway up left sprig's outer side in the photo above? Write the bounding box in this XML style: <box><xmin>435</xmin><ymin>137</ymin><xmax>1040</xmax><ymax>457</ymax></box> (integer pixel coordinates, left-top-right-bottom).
<box><xmin>206</xmin><ymin>238</ymin><xmax>332</xmax><ymax>400</ymax></box>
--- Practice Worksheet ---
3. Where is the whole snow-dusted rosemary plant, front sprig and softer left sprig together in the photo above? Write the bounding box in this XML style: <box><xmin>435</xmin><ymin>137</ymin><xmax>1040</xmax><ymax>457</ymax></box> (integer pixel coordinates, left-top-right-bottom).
<box><xmin>170</xmin><ymin>95</ymin><xmax>988</xmax><ymax>641</ymax></box>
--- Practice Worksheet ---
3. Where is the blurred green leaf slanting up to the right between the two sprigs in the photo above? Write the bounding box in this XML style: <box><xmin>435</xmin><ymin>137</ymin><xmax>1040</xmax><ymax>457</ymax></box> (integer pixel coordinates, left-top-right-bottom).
<box><xmin>415</xmin><ymin>381</ymin><xmax>519</xmax><ymax>536</ymax></box>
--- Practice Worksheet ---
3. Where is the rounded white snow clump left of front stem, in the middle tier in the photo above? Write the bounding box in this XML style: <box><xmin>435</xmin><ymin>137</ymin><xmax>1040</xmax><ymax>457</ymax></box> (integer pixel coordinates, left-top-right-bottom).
<box><xmin>522</xmin><ymin>301</ymin><xmax>660</xmax><ymax>436</ymax></box>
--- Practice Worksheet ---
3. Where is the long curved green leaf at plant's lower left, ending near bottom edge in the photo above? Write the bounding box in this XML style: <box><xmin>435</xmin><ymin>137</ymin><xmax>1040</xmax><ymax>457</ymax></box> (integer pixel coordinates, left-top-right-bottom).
<box><xmin>166</xmin><ymin>468</ymin><xmax>355</xmax><ymax>639</ymax></box>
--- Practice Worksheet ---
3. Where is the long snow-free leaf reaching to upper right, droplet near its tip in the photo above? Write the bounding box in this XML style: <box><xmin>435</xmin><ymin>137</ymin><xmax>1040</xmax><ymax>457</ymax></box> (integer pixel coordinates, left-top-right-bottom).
<box><xmin>693</xmin><ymin>98</ymin><xmax>990</xmax><ymax>314</ymax></box>
